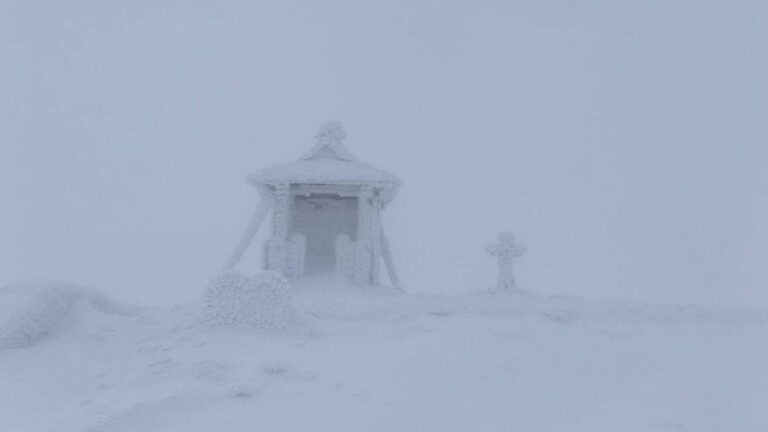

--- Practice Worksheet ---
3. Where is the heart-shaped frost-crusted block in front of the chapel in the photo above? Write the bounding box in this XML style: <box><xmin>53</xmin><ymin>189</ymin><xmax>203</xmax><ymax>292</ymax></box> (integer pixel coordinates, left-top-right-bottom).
<box><xmin>205</xmin><ymin>271</ymin><xmax>297</xmax><ymax>330</ymax></box>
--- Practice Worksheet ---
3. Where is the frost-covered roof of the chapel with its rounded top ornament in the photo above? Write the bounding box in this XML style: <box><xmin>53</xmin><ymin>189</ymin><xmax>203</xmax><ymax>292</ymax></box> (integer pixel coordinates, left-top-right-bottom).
<box><xmin>248</xmin><ymin>121</ymin><xmax>400</xmax><ymax>189</ymax></box>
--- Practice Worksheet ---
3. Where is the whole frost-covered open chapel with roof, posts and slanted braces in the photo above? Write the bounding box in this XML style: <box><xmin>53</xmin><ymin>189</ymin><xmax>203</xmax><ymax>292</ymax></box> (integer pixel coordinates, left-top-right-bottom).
<box><xmin>225</xmin><ymin>121</ymin><xmax>400</xmax><ymax>287</ymax></box>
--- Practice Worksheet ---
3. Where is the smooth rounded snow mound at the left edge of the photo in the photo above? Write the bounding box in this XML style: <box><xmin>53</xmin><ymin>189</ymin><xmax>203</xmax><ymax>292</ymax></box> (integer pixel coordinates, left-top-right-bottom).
<box><xmin>0</xmin><ymin>281</ymin><xmax>138</xmax><ymax>351</ymax></box>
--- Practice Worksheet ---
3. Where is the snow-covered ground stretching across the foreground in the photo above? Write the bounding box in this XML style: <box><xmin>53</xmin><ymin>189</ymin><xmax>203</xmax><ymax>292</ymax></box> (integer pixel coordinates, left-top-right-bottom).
<box><xmin>0</xmin><ymin>287</ymin><xmax>768</xmax><ymax>432</ymax></box>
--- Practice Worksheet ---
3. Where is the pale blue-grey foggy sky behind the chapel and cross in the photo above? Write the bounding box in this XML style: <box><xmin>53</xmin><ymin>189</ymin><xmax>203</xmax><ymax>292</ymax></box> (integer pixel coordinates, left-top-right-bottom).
<box><xmin>0</xmin><ymin>0</ymin><xmax>768</xmax><ymax>306</ymax></box>
